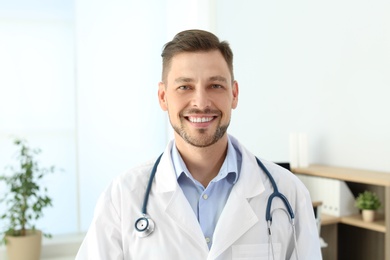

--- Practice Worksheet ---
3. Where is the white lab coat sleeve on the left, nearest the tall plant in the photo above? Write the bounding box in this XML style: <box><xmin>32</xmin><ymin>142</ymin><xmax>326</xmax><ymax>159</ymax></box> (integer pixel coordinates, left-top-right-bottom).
<box><xmin>76</xmin><ymin>183</ymin><xmax>124</xmax><ymax>260</ymax></box>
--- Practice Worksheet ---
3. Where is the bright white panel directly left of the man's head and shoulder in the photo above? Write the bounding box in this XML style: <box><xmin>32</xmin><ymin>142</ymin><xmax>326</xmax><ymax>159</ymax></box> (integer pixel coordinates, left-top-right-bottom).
<box><xmin>76</xmin><ymin>0</ymin><xmax>166</xmax><ymax>230</ymax></box>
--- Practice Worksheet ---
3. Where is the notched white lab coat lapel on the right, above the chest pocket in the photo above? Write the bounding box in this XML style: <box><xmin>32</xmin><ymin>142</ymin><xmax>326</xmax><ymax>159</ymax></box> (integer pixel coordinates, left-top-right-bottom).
<box><xmin>208</xmin><ymin>151</ymin><xmax>264</xmax><ymax>259</ymax></box>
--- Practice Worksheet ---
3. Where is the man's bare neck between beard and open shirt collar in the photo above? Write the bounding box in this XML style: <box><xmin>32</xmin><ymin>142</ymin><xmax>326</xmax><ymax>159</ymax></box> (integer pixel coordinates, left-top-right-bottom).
<box><xmin>175</xmin><ymin>134</ymin><xmax>228</xmax><ymax>187</ymax></box>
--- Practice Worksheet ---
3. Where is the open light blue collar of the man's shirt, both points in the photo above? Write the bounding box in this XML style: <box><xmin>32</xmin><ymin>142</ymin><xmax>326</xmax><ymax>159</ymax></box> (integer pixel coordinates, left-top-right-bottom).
<box><xmin>171</xmin><ymin>137</ymin><xmax>239</xmax><ymax>184</ymax></box>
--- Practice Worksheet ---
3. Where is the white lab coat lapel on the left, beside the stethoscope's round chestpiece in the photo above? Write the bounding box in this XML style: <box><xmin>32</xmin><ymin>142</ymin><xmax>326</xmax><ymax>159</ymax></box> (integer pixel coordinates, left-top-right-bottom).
<box><xmin>155</xmin><ymin>148</ymin><xmax>208</xmax><ymax>254</ymax></box>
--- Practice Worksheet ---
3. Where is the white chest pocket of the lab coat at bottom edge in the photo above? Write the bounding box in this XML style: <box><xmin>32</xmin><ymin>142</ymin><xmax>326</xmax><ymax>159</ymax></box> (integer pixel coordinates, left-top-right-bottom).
<box><xmin>232</xmin><ymin>243</ymin><xmax>282</xmax><ymax>260</ymax></box>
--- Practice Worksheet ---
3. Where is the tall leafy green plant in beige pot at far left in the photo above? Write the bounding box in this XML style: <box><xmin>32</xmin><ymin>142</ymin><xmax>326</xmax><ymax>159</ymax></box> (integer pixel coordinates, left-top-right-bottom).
<box><xmin>0</xmin><ymin>139</ymin><xmax>55</xmax><ymax>260</ymax></box>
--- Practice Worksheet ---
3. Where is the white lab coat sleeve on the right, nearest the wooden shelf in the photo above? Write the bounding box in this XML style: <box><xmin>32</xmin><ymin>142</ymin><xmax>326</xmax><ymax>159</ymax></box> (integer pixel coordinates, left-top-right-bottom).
<box><xmin>291</xmin><ymin>185</ymin><xmax>322</xmax><ymax>260</ymax></box>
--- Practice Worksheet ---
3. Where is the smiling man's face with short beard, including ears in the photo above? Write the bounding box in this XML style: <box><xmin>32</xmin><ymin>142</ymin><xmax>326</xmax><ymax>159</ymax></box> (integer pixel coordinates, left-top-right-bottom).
<box><xmin>158</xmin><ymin>50</ymin><xmax>238</xmax><ymax>147</ymax></box>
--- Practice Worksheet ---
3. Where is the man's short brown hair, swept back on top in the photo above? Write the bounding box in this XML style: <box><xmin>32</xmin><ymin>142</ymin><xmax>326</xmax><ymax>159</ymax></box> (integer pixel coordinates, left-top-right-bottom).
<box><xmin>161</xmin><ymin>30</ymin><xmax>234</xmax><ymax>80</ymax></box>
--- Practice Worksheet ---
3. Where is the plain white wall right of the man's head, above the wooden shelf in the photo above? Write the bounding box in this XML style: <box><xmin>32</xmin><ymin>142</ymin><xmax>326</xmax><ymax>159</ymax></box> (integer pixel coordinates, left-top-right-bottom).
<box><xmin>216</xmin><ymin>0</ymin><xmax>390</xmax><ymax>171</ymax></box>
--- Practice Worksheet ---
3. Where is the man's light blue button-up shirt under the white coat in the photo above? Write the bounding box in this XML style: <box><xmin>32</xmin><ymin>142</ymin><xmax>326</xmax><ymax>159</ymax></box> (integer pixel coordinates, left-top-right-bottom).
<box><xmin>171</xmin><ymin>139</ymin><xmax>241</xmax><ymax>248</ymax></box>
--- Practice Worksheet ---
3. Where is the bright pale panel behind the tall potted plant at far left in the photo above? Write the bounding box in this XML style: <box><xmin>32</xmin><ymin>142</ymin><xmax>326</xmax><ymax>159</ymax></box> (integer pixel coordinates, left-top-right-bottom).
<box><xmin>0</xmin><ymin>0</ymin><xmax>77</xmax><ymax>234</ymax></box>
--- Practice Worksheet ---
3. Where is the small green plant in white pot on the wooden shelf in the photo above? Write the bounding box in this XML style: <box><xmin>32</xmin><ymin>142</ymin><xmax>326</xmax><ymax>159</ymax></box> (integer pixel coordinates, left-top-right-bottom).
<box><xmin>355</xmin><ymin>190</ymin><xmax>382</xmax><ymax>222</ymax></box>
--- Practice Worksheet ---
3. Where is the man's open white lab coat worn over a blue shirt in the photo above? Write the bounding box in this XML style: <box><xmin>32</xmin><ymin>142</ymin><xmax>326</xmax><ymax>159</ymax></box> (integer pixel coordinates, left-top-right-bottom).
<box><xmin>76</xmin><ymin>137</ymin><xmax>321</xmax><ymax>260</ymax></box>
